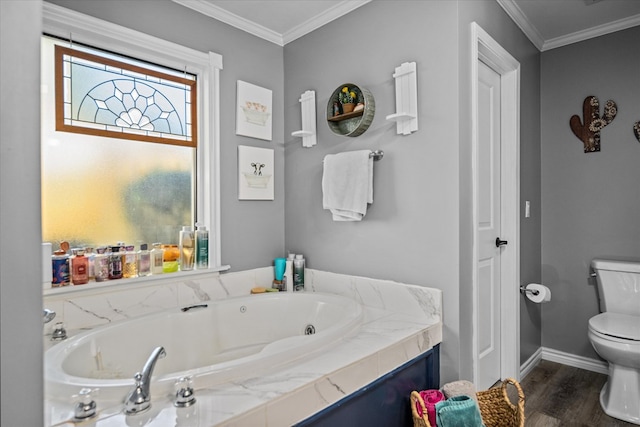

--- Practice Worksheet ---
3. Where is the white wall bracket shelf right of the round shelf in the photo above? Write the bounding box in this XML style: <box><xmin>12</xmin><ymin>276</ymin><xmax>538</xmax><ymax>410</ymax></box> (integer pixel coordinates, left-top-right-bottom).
<box><xmin>387</xmin><ymin>62</ymin><xmax>418</xmax><ymax>135</ymax></box>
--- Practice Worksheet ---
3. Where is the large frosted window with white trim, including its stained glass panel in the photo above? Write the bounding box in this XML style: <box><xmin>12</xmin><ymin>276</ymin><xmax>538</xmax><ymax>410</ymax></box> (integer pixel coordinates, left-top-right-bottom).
<box><xmin>41</xmin><ymin>4</ymin><xmax>222</xmax><ymax>269</ymax></box>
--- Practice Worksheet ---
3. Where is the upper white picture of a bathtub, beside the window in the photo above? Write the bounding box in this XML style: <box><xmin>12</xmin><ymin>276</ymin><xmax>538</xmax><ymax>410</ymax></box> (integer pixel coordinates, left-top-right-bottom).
<box><xmin>236</xmin><ymin>80</ymin><xmax>273</xmax><ymax>141</ymax></box>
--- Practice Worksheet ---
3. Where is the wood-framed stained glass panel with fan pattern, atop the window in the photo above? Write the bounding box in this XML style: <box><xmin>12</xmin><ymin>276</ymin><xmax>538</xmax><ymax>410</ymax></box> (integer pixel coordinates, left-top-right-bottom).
<box><xmin>55</xmin><ymin>46</ymin><xmax>197</xmax><ymax>147</ymax></box>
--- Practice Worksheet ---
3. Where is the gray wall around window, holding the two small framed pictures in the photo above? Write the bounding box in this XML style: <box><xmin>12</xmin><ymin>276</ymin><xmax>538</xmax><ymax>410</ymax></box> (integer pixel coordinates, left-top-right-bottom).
<box><xmin>51</xmin><ymin>0</ymin><xmax>284</xmax><ymax>271</ymax></box>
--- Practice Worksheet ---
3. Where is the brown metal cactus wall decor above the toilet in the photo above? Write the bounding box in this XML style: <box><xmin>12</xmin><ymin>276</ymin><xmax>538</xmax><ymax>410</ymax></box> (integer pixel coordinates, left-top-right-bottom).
<box><xmin>569</xmin><ymin>96</ymin><xmax>618</xmax><ymax>153</ymax></box>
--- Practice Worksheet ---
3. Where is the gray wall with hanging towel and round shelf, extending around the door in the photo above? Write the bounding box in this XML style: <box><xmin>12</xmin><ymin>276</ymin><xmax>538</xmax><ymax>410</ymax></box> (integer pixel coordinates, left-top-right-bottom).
<box><xmin>284</xmin><ymin>1</ymin><xmax>540</xmax><ymax>381</ymax></box>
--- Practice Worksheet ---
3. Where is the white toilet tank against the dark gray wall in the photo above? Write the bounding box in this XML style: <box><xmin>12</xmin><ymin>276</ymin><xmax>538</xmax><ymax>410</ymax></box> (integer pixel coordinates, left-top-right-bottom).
<box><xmin>591</xmin><ymin>259</ymin><xmax>640</xmax><ymax>316</ymax></box>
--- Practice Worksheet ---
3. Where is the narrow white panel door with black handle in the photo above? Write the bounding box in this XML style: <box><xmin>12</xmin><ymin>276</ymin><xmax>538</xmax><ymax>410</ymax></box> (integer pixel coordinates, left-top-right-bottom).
<box><xmin>475</xmin><ymin>60</ymin><xmax>501</xmax><ymax>390</ymax></box>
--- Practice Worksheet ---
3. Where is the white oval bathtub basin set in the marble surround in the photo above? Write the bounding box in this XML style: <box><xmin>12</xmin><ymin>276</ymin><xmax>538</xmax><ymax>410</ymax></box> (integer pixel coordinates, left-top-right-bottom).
<box><xmin>44</xmin><ymin>292</ymin><xmax>363</xmax><ymax>404</ymax></box>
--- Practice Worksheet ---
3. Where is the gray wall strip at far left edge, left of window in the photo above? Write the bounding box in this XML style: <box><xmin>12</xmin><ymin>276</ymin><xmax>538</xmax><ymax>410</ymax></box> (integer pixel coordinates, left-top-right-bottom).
<box><xmin>0</xmin><ymin>1</ymin><xmax>44</xmax><ymax>426</ymax></box>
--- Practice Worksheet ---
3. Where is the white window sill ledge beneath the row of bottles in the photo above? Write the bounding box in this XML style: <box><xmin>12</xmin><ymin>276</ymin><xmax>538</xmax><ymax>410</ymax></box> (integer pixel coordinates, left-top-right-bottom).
<box><xmin>42</xmin><ymin>265</ymin><xmax>231</xmax><ymax>297</ymax></box>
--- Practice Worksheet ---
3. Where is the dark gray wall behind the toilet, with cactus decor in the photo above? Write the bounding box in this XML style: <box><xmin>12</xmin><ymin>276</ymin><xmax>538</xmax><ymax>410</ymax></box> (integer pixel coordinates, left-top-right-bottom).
<box><xmin>541</xmin><ymin>27</ymin><xmax>640</xmax><ymax>358</ymax></box>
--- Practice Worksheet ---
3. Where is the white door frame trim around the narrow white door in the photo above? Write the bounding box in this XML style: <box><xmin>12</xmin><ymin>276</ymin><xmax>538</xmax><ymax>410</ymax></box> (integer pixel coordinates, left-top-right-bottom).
<box><xmin>471</xmin><ymin>22</ymin><xmax>520</xmax><ymax>383</ymax></box>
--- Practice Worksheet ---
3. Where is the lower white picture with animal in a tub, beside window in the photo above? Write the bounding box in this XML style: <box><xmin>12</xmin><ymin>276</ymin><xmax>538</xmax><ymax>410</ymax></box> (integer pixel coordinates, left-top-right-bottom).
<box><xmin>238</xmin><ymin>145</ymin><xmax>274</xmax><ymax>200</ymax></box>
